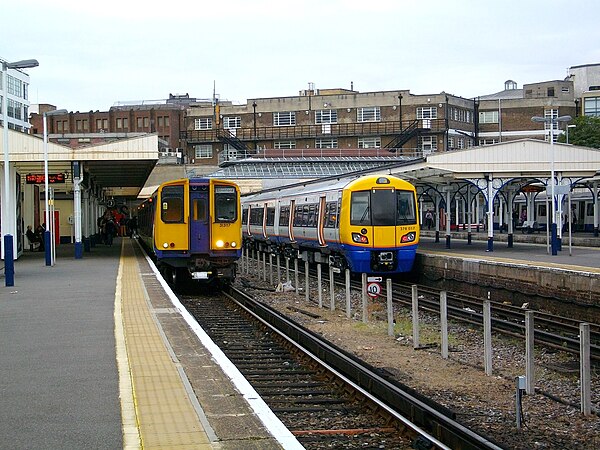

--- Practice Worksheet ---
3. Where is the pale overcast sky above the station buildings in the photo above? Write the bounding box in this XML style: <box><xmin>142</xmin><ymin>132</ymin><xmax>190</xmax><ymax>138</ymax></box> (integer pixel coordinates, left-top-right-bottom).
<box><xmin>0</xmin><ymin>0</ymin><xmax>600</xmax><ymax>111</ymax></box>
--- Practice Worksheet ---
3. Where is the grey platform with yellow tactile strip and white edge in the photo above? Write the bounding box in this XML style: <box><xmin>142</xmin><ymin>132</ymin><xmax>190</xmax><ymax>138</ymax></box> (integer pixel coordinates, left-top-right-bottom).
<box><xmin>0</xmin><ymin>238</ymin><xmax>301</xmax><ymax>449</ymax></box>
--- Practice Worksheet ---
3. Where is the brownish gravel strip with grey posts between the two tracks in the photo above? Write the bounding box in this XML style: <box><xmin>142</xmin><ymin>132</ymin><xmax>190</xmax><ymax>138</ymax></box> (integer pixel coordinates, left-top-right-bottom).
<box><xmin>236</xmin><ymin>274</ymin><xmax>600</xmax><ymax>449</ymax></box>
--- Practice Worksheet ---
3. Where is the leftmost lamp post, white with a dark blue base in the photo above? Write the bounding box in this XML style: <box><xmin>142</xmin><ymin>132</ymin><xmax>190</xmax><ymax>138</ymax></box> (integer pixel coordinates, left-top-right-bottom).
<box><xmin>2</xmin><ymin>59</ymin><xmax>39</xmax><ymax>286</ymax></box>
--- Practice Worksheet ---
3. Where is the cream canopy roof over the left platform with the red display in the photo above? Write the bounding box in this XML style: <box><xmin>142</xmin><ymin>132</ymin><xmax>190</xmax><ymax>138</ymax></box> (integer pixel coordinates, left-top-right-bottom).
<box><xmin>0</xmin><ymin>126</ymin><xmax>159</xmax><ymax>197</ymax></box>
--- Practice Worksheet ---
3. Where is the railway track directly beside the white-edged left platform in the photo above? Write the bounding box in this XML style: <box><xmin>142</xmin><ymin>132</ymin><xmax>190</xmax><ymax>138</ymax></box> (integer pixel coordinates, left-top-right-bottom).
<box><xmin>182</xmin><ymin>288</ymin><xmax>500</xmax><ymax>449</ymax></box>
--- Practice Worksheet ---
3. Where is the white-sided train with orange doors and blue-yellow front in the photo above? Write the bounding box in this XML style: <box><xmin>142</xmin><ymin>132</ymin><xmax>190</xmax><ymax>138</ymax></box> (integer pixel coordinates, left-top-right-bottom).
<box><xmin>241</xmin><ymin>175</ymin><xmax>420</xmax><ymax>275</ymax></box>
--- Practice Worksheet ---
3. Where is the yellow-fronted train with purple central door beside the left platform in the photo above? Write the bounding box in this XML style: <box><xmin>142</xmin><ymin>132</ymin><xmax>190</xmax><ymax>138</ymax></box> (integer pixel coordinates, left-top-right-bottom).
<box><xmin>138</xmin><ymin>178</ymin><xmax>242</xmax><ymax>286</ymax></box>
